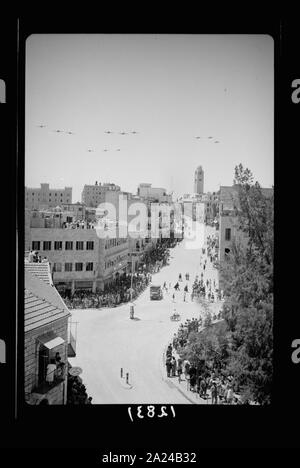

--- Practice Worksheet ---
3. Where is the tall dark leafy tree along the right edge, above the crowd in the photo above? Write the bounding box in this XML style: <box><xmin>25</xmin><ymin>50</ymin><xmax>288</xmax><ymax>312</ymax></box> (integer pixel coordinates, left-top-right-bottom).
<box><xmin>185</xmin><ymin>164</ymin><xmax>274</xmax><ymax>404</ymax></box>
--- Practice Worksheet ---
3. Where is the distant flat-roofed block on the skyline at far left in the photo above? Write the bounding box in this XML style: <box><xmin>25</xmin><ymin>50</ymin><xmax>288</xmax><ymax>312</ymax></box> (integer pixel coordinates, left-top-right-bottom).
<box><xmin>25</xmin><ymin>184</ymin><xmax>72</xmax><ymax>210</ymax></box>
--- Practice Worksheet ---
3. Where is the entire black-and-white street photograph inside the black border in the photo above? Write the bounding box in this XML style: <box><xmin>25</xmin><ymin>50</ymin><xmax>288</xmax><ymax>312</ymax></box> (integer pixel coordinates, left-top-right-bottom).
<box><xmin>24</xmin><ymin>33</ymin><xmax>274</xmax><ymax>411</ymax></box>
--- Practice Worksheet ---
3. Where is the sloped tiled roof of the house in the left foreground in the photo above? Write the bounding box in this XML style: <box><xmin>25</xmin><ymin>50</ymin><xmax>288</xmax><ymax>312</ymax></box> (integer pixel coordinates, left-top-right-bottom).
<box><xmin>24</xmin><ymin>271</ymin><xmax>71</xmax><ymax>333</ymax></box>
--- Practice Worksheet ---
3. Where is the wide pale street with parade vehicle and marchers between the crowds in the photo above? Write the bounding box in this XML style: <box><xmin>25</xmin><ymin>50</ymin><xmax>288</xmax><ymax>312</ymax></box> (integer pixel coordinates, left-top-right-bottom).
<box><xmin>69</xmin><ymin>227</ymin><xmax>217</xmax><ymax>404</ymax></box>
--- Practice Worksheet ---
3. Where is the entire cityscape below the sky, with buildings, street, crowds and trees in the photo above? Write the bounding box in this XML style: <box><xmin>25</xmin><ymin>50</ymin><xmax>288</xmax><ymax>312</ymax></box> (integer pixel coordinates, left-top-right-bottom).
<box><xmin>24</xmin><ymin>164</ymin><xmax>273</xmax><ymax>405</ymax></box>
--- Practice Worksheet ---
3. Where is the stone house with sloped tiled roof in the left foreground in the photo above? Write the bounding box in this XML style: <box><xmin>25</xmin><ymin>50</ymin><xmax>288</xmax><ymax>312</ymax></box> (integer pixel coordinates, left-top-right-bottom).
<box><xmin>24</xmin><ymin>261</ymin><xmax>71</xmax><ymax>405</ymax></box>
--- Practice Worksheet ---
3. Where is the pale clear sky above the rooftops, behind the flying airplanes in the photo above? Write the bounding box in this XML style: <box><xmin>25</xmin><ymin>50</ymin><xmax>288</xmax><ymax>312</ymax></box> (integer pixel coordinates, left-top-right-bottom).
<box><xmin>25</xmin><ymin>34</ymin><xmax>274</xmax><ymax>202</ymax></box>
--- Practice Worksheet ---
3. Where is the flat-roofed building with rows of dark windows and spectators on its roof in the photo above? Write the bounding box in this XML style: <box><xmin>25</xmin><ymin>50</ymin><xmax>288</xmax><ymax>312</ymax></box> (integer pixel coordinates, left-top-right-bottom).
<box><xmin>30</xmin><ymin>218</ymin><xmax>128</xmax><ymax>292</ymax></box>
